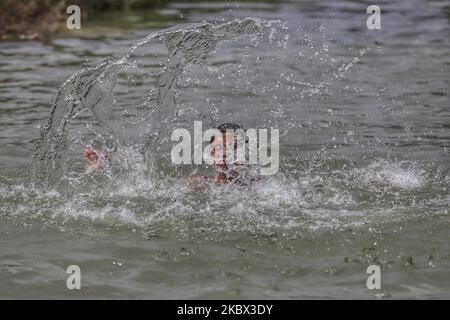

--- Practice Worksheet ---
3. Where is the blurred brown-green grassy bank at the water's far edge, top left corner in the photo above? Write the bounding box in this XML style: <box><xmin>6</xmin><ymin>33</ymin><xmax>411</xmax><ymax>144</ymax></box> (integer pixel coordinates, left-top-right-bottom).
<box><xmin>0</xmin><ymin>0</ymin><xmax>169</xmax><ymax>40</ymax></box>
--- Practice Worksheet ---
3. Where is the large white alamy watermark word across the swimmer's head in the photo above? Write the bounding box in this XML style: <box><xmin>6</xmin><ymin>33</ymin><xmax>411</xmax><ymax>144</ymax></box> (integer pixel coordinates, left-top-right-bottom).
<box><xmin>170</xmin><ymin>121</ymin><xmax>280</xmax><ymax>175</ymax></box>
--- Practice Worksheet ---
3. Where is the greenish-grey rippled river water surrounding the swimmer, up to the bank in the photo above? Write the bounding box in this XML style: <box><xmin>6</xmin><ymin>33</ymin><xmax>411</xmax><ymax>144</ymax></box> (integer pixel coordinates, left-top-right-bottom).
<box><xmin>0</xmin><ymin>0</ymin><xmax>450</xmax><ymax>299</ymax></box>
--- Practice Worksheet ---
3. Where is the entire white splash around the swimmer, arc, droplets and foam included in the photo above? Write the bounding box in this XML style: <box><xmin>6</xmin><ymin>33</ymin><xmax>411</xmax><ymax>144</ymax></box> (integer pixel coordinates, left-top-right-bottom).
<box><xmin>22</xmin><ymin>18</ymin><xmax>444</xmax><ymax>237</ymax></box>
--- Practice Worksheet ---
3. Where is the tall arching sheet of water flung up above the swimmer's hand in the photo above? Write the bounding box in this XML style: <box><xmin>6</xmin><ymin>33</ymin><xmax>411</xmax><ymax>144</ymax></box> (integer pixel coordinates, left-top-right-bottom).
<box><xmin>33</xmin><ymin>19</ymin><xmax>271</xmax><ymax>187</ymax></box>
